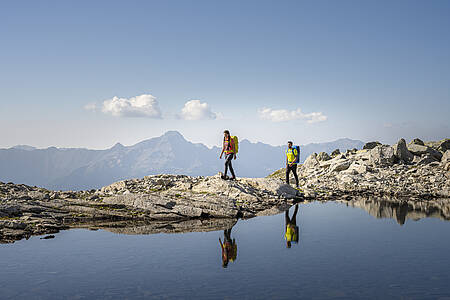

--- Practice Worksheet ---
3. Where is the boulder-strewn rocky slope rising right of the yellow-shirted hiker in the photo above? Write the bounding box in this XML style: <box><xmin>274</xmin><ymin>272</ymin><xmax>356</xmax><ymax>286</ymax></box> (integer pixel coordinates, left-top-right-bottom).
<box><xmin>269</xmin><ymin>139</ymin><xmax>450</xmax><ymax>200</ymax></box>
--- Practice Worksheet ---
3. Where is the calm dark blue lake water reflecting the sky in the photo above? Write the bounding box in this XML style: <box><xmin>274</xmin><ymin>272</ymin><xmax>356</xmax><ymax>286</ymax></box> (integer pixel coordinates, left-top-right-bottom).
<box><xmin>0</xmin><ymin>203</ymin><xmax>450</xmax><ymax>299</ymax></box>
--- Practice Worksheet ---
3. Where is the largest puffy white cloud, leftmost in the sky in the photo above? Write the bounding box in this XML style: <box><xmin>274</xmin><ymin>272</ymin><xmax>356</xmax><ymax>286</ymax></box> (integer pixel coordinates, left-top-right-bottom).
<box><xmin>100</xmin><ymin>94</ymin><xmax>162</xmax><ymax>119</ymax></box>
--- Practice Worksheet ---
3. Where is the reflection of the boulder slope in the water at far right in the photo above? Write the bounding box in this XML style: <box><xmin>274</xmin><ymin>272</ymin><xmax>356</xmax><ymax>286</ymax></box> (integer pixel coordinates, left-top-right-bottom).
<box><xmin>339</xmin><ymin>197</ymin><xmax>450</xmax><ymax>225</ymax></box>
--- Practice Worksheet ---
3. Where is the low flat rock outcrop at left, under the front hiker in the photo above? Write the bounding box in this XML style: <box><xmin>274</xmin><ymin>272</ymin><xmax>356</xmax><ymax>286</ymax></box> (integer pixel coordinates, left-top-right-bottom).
<box><xmin>0</xmin><ymin>175</ymin><xmax>302</xmax><ymax>242</ymax></box>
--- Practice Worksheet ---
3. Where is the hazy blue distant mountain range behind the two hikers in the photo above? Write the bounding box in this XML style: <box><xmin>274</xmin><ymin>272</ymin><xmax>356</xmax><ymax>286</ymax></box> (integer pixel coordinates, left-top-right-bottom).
<box><xmin>0</xmin><ymin>131</ymin><xmax>363</xmax><ymax>190</ymax></box>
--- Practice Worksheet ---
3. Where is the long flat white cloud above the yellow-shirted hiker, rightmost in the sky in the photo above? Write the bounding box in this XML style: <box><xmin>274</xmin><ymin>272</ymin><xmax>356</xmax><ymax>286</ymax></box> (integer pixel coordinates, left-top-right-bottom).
<box><xmin>258</xmin><ymin>107</ymin><xmax>328</xmax><ymax>124</ymax></box>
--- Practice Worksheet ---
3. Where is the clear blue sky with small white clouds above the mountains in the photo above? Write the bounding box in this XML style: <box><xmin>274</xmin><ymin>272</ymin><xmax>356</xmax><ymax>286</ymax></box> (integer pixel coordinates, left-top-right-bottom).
<box><xmin>0</xmin><ymin>0</ymin><xmax>450</xmax><ymax>149</ymax></box>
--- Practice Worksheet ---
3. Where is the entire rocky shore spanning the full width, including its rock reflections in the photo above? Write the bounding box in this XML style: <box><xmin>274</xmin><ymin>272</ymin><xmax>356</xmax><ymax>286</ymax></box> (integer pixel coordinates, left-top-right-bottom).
<box><xmin>0</xmin><ymin>139</ymin><xmax>450</xmax><ymax>243</ymax></box>
